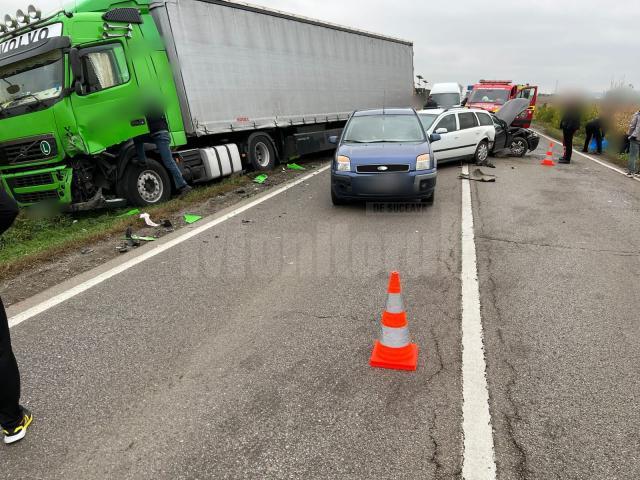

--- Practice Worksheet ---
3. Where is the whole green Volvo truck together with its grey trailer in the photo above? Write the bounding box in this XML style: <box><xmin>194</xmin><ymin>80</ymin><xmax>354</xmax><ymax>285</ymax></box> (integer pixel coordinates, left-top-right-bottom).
<box><xmin>0</xmin><ymin>0</ymin><xmax>414</xmax><ymax>211</ymax></box>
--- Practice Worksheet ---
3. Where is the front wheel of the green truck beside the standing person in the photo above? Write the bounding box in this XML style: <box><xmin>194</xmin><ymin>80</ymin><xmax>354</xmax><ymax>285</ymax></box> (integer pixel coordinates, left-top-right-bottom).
<box><xmin>123</xmin><ymin>158</ymin><xmax>171</xmax><ymax>207</ymax></box>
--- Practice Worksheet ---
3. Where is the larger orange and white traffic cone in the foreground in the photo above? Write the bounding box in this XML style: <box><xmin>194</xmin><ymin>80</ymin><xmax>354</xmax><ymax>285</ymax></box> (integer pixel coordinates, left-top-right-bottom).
<box><xmin>369</xmin><ymin>272</ymin><xmax>418</xmax><ymax>370</ymax></box>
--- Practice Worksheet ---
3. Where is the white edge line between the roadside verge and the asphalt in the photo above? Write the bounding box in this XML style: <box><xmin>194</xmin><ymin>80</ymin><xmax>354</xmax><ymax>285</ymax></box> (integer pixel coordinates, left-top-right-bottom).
<box><xmin>9</xmin><ymin>165</ymin><xmax>330</xmax><ymax>328</ymax></box>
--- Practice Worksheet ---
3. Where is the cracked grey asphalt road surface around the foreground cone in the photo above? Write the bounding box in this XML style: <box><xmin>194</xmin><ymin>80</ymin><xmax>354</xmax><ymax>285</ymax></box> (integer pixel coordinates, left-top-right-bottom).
<box><xmin>0</xmin><ymin>142</ymin><xmax>640</xmax><ymax>480</ymax></box>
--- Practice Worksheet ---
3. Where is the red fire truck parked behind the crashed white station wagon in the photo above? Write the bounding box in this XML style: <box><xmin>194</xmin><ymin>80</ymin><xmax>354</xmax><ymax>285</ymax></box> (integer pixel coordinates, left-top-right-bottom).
<box><xmin>466</xmin><ymin>80</ymin><xmax>538</xmax><ymax>128</ymax></box>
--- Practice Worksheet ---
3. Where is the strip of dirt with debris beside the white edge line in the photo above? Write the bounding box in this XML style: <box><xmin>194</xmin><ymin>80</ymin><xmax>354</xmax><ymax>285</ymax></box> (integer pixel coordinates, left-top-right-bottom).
<box><xmin>0</xmin><ymin>156</ymin><xmax>328</xmax><ymax>306</ymax></box>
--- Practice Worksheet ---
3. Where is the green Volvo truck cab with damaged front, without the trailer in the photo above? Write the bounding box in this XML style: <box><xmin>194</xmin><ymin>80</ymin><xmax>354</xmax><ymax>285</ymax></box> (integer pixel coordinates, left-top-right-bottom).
<box><xmin>0</xmin><ymin>0</ymin><xmax>187</xmax><ymax>210</ymax></box>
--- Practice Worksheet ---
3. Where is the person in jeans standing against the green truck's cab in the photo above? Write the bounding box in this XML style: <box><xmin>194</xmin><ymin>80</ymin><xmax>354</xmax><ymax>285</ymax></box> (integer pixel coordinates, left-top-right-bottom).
<box><xmin>133</xmin><ymin>105</ymin><xmax>192</xmax><ymax>195</ymax></box>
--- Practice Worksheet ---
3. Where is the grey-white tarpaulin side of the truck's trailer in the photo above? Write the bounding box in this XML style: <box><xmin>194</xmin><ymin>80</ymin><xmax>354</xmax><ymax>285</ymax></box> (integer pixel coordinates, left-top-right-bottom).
<box><xmin>154</xmin><ymin>0</ymin><xmax>413</xmax><ymax>135</ymax></box>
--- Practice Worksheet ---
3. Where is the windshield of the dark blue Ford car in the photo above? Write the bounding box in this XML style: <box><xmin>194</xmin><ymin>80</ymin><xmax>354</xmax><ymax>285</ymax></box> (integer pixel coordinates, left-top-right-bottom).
<box><xmin>344</xmin><ymin>115</ymin><xmax>425</xmax><ymax>143</ymax></box>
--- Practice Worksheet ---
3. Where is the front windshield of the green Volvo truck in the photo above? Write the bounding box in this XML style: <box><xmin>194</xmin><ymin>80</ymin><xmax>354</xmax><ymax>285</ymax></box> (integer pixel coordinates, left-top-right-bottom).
<box><xmin>0</xmin><ymin>51</ymin><xmax>64</xmax><ymax>110</ymax></box>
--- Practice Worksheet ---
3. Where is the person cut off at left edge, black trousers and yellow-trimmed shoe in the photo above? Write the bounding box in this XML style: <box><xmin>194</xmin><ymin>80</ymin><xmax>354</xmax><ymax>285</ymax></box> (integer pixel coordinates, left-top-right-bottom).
<box><xmin>0</xmin><ymin>186</ymin><xmax>33</xmax><ymax>444</ymax></box>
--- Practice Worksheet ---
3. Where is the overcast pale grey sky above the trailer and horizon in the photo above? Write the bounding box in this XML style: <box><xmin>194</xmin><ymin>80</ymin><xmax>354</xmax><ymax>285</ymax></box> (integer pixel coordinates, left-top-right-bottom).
<box><xmin>0</xmin><ymin>0</ymin><xmax>640</xmax><ymax>92</ymax></box>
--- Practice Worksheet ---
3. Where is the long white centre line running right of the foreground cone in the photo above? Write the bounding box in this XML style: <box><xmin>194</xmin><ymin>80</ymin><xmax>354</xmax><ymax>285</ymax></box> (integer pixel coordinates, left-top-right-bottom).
<box><xmin>461</xmin><ymin>165</ymin><xmax>496</xmax><ymax>480</ymax></box>
